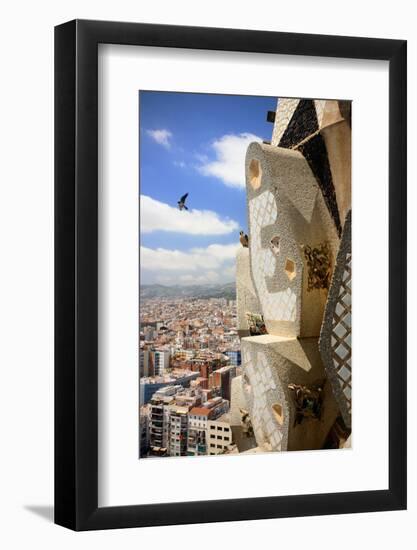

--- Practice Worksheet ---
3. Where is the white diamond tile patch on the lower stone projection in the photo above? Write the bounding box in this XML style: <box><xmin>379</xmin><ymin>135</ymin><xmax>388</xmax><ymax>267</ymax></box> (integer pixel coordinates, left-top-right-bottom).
<box><xmin>242</xmin><ymin>347</ymin><xmax>282</xmax><ymax>451</ymax></box>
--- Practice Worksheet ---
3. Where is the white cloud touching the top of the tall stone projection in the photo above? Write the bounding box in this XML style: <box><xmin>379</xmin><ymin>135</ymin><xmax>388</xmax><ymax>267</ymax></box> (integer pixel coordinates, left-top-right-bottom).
<box><xmin>197</xmin><ymin>133</ymin><xmax>262</xmax><ymax>188</ymax></box>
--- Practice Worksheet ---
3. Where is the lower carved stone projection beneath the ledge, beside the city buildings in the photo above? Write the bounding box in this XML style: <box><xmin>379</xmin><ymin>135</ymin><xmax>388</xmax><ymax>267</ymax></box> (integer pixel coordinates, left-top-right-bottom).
<box><xmin>242</xmin><ymin>335</ymin><xmax>338</xmax><ymax>451</ymax></box>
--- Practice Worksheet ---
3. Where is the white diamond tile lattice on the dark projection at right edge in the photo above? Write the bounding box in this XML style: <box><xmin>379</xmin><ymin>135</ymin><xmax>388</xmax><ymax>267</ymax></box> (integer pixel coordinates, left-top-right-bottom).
<box><xmin>331</xmin><ymin>254</ymin><xmax>352</xmax><ymax>413</ymax></box>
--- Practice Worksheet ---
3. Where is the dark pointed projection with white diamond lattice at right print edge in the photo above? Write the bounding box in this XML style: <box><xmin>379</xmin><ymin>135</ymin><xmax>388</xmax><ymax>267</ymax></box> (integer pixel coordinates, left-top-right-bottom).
<box><xmin>319</xmin><ymin>212</ymin><xmax>352</xmax><ymax>427</ymax></box>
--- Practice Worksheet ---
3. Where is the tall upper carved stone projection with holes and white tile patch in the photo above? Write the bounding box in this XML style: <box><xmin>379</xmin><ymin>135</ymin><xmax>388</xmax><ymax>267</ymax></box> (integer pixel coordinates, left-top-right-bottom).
<box><xmin>246</xmin><ymin>143</ymin><xmax>339</xmax><ymax>337</ymax></box>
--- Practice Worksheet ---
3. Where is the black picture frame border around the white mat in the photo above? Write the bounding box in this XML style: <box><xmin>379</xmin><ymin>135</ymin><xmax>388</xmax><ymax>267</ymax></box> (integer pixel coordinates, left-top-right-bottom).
<box><xmin>55</xmin><ymin>20</ymin><xmax>407</xmax><ymax>531</ymax></box>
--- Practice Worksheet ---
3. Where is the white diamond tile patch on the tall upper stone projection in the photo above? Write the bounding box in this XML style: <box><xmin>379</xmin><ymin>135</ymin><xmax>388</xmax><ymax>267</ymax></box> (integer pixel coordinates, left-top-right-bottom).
<box><xmin>249</xmin><ymin>191</ymin><xmax>297</xmax><ymax>321</ymax></box>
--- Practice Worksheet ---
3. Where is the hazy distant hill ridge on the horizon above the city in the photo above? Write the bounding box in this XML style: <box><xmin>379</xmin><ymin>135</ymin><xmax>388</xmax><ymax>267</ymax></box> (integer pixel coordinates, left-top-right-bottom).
<box><xmin>140</xmin><ymin>283</ymin><xmax>236</xmax><ymax>300</ymax></box>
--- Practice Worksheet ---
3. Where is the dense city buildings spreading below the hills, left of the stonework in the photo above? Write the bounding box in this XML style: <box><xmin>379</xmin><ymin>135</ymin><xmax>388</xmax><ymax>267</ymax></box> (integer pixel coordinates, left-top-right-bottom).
<box><xmin>140</xmin><ymin>298</ymin><xmax>256</xmax><ymax>457</ymax></box>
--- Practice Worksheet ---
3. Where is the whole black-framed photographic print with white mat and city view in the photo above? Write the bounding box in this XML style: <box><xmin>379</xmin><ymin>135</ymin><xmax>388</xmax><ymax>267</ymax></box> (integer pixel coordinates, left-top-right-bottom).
<box><xmin>55</xmin><ymin>21</ymin><xmax>406</xmax><ymax>530</ymax></box>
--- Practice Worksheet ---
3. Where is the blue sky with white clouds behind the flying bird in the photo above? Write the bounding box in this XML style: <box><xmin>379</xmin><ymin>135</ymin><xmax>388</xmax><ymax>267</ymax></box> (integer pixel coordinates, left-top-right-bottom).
<box><xmin>139</xmin><ymin>91</ymin><xmax>277</xmax><ymax>284</ymax></box>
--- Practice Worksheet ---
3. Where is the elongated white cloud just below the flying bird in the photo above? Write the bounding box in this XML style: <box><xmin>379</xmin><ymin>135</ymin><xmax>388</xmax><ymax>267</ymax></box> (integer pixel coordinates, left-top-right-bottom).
<box><xmin>140</xmin><ymin>195</ymin><xmax>239</xmax><ymax>235</ymax></box>
